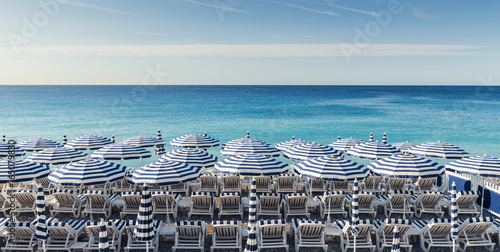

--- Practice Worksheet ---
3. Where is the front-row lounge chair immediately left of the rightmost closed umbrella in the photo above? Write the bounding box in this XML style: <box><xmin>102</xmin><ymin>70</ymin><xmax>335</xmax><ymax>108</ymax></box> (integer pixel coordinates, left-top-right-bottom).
<box><xmin>413</xmin><ymin>218</ymin><xmax>453</xmax><ymax>252</ymax></box>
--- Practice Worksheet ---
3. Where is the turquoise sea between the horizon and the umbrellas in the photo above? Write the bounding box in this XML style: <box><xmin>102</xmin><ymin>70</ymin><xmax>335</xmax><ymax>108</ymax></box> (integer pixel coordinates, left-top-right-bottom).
<box><xmin>0</xmin><ymin>86</ymin><xmax>500</xmax><ymax>166</ymax></box>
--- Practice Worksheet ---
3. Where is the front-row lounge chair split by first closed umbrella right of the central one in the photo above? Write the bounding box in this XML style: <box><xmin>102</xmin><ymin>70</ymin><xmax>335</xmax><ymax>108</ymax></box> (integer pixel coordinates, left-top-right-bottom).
<box><xmin>335</xmin><ymin>219</ymin><xmax>376</xmax><ymax>252</ymax></box>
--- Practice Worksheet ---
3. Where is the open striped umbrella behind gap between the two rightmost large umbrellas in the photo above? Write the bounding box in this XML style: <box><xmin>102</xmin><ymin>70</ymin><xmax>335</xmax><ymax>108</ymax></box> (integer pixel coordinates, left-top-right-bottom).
<box><xmin>408</xmin><ymin>141</ymin><xmax>470</xmax><ymax>159</ymax></box>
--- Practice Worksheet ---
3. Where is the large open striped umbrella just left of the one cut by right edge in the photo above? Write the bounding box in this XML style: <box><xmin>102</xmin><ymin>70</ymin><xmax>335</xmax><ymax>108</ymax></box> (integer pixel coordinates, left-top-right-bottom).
<box><xmin>368</xmin><ymin>154</ymin><xmax>445</xmax><ymax>178</ymax></box>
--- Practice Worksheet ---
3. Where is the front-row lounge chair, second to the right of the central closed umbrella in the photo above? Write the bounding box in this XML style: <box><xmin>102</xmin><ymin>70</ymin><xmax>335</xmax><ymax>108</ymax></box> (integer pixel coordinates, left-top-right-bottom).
<box><xmin>292</xmin><ymin>219</ymin><xmax>328</xmax><ymax>252</ymax></box>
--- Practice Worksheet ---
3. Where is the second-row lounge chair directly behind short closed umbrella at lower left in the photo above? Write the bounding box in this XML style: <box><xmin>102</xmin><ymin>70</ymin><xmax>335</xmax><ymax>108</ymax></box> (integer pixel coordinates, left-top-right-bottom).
<box><xmin>82</xmin><ymin>190</ymin><xmax>118</xmax><ymax>219</ymax></box>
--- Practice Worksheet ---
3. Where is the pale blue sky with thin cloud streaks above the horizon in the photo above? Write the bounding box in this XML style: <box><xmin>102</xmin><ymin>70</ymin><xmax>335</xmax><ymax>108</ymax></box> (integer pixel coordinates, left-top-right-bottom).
<box><xmin>0</xmin><ymin>0</ymin><xmax>500</xmax><ymax>85</ymax></box>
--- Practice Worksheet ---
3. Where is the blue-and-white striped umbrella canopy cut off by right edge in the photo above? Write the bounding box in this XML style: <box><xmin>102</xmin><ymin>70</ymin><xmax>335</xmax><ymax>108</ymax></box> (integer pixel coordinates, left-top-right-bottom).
<box><xmin>446</xmin><ymin>155</ymin><xmax>500</xmax><ymax>177</ymax></box>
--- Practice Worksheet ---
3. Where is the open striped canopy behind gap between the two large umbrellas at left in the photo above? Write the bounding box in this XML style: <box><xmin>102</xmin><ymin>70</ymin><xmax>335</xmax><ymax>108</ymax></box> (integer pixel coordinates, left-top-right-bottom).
<box><xmin>91</xmin><ymin>143</ymin><xmax>151</xmax><ymax>160</ymax></box>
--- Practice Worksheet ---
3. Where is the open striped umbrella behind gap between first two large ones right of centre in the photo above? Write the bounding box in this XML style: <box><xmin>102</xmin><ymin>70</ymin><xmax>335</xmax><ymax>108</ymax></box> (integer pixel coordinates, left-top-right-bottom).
<box><xmin>347</xmin><ymin>142</ymin><xmax>401</xmax><ymax>160</ymax></box>
